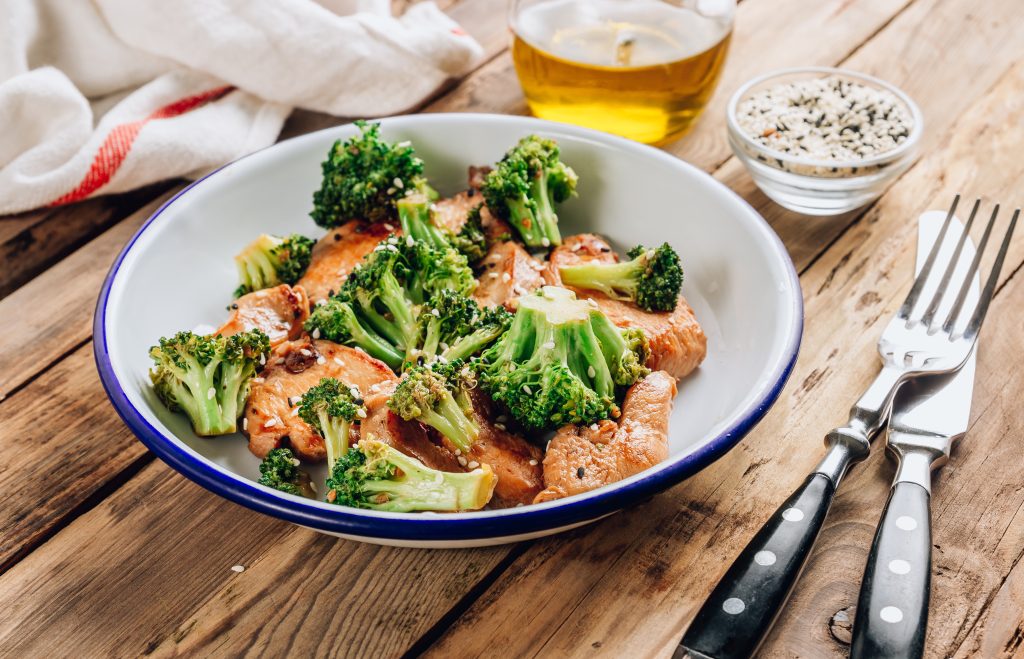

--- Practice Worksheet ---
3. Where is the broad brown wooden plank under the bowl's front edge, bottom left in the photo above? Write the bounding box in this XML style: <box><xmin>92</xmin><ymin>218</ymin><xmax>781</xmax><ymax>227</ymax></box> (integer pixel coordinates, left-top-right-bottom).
<box><xmin>0</xmin><ymin>463</ymin><xmax>516</xmax><ymax>657</ymax></box>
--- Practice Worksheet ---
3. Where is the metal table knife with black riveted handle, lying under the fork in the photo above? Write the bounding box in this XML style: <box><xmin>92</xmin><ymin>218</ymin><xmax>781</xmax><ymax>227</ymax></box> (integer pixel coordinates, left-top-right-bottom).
<box><xmin>850</xmin><ymin>220</ymin><xmax>978</xmax><ymax>659</ymax></box>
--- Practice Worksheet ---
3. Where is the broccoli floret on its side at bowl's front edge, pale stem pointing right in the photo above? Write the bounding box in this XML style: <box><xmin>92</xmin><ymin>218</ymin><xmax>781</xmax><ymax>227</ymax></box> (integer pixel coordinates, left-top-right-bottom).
<box><xmin>327</xmin><ymin>439</ymin><xmax>498</xmax><ymax>513</ymax></box>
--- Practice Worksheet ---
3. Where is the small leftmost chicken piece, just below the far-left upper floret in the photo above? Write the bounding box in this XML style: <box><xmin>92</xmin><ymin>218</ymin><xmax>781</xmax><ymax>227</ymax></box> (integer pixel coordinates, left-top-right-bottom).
<box><xmin>217</xmin><ymin>283</ymin><xmax>309</xmax><ymax>346</ymax></box>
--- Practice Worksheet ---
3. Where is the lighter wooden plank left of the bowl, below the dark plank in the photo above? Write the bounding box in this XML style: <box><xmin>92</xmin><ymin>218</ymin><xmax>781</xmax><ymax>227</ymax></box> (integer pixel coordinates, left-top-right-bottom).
<box><xmin>0</xmin><ymin>187</ymin><xmax>177</xmax><ymax>400</ymax></box>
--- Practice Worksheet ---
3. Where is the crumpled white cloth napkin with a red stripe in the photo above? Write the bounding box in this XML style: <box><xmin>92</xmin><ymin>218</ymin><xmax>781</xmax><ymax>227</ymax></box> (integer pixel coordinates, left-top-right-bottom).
<box><xmin>0</xmin><ymin>0</ymin><xmax>482</xmax><ymax>214</ymax></box>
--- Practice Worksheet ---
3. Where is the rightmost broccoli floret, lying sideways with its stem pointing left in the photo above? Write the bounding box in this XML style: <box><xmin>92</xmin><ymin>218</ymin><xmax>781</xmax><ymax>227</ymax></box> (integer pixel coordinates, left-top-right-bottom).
<box><xmin>558</xmin><ymin>243</ymin><xmax>683</xmax><ymax>311</ymax></box>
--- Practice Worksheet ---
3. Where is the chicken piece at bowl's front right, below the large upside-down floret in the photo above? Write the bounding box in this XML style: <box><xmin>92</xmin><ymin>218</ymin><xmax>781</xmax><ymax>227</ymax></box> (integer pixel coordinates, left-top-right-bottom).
<box><xmin>534</xmin><ymin>370</ymin><xmax>676</xmax><ymax>503</ymax></box>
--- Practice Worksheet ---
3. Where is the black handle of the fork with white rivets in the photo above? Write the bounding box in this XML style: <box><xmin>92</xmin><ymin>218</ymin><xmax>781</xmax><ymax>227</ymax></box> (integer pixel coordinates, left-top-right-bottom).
<box><xmin>677</xmin><ymin>473</ymin><xmax>836</xmax><ymax>659</ymax></box>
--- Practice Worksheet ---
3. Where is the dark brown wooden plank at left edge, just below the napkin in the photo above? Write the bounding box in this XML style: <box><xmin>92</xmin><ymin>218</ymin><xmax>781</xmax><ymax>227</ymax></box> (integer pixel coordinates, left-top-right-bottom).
<box><xmin>0</xmin><ymin>181</ymin><xmax>174</xmax><ymax>298</ymax></box>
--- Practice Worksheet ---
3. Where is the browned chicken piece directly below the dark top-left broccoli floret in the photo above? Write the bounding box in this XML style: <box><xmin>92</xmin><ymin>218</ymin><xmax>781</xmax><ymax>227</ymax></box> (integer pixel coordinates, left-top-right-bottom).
<box><xmin>298</xmin><ymin>220</ymin><xmax>399</xmax><ymax>303</ymax></box>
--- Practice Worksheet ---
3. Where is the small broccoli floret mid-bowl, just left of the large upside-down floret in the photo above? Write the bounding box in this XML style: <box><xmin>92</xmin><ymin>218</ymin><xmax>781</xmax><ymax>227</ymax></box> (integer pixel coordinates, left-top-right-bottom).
<box><xmin>407</xmin><ymin>291</ymin><xmax>512</xmax><ymax>362</ymax></box>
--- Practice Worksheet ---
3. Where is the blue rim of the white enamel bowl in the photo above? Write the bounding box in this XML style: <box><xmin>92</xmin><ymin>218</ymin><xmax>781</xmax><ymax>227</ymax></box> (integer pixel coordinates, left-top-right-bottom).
<box><xmin>93</xmin><ymin>113</ymin><xmax>804</xmax><ymax>542</ymax></box>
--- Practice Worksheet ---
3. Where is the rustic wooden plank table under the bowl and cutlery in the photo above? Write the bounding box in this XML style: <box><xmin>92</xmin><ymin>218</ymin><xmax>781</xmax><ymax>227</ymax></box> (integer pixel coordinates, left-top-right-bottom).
<box><xmin>0</xmin><ymin>0</ymin><xmax>1024</xmax><ymax>657</ymax></box>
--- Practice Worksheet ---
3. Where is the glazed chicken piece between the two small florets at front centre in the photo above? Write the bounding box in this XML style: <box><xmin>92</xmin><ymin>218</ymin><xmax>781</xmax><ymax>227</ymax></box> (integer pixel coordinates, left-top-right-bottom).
<box><xmin>359</xmin><ymin>380</ymin><xmax>465</xmax><ymax>472</ymax></box>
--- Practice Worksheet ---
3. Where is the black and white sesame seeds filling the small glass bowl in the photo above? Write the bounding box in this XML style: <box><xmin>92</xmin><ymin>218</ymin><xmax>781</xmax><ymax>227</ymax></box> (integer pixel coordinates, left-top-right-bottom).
<box><xmin>736</xmin><ymin>75</ymin><xmax>913</xmax><ymax>177</ymax></box>
